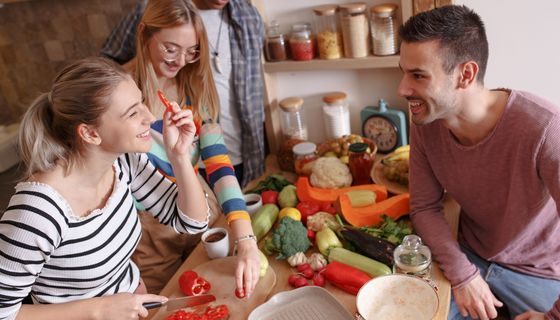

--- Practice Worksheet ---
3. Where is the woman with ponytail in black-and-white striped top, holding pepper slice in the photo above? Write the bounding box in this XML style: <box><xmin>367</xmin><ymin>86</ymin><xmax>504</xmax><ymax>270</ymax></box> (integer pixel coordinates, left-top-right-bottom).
<box><xmin>0</xmin><ymin>57</ymin><xmax>209</xmax><ymax>320</ymax></box>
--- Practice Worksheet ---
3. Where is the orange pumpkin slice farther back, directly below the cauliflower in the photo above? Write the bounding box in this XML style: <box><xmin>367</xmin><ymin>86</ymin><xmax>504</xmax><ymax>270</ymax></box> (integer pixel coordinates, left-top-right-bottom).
<box><xmin>296</xmin><ymin>177</ymin><xmax>387</xmax><ymax>203</ymax></box>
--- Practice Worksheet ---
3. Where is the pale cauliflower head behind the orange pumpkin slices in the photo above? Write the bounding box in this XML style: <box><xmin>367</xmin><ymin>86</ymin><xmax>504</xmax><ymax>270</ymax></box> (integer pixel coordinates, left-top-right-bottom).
<box><xmin>309</xmin><ymin>157</ymin><xmax>352</xmax><ymax>189</ymax></box>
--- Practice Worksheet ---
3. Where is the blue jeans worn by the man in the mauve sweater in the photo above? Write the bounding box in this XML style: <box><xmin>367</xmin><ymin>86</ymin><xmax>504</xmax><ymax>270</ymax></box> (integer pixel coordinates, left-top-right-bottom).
<box><xmin>447</xmin><ymin>248</ymin><xmax>560</xmax><ymax>320</ymax></box>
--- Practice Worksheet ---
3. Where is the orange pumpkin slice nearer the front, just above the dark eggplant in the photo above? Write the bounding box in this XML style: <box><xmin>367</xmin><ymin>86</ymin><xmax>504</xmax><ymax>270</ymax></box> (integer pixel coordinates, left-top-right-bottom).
<box><xmin>337</xmin><ymin>193</ymin><xmax>410</xmax><ymax>227</ymax></box>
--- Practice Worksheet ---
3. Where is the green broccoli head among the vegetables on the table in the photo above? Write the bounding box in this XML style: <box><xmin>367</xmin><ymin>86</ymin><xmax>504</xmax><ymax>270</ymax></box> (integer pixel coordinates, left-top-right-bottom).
<box><xmin>264</xmin><ymin>217</ymin><xmax>311</xmax><ymax>259</ymax></box>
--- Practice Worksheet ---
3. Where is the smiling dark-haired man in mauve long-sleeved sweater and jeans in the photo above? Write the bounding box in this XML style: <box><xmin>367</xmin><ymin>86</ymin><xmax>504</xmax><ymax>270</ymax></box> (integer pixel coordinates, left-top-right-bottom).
<box><xmin>398</xmin><ymin>5</ymin><xmax>560</xmax><ymax>320</ymax></box>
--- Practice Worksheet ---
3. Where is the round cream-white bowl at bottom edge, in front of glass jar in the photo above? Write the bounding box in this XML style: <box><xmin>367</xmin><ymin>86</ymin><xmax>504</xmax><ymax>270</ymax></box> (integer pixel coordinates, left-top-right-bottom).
<box><xmin>356</xmin><ymin>274</ymin><xmax>439</xmax><ymax>320</ymax></box>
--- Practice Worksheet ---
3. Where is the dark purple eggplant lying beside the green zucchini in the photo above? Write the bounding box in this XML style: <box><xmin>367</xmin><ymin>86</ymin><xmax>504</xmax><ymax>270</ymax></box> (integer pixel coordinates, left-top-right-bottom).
<box><xmin>340</xmin><ymin>226</ymin><xmax>396</xmax><ymax>266</ymax></box>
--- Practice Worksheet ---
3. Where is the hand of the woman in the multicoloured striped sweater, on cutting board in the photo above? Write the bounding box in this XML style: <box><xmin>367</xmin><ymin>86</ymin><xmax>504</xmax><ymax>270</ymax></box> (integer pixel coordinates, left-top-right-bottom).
<box><xmin>235</xmin><ymin>240</ymin><xmax>260</xmax><ymax>297</ymax></box>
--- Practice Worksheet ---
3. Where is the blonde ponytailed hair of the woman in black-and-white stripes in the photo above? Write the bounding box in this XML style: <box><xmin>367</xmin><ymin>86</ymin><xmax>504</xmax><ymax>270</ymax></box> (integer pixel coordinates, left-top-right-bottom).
<box><xmin>19</xmin><ymin>57</ymin><xmax>130</xmax><ymax>178</ymax></box>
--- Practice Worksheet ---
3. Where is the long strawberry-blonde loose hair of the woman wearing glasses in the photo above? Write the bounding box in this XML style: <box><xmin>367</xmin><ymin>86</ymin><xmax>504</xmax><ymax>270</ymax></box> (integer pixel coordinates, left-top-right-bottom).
<box><xmin>134</xmin><ymin>0</ymin><xmax>220</xmax><ymax>120</ymax></box>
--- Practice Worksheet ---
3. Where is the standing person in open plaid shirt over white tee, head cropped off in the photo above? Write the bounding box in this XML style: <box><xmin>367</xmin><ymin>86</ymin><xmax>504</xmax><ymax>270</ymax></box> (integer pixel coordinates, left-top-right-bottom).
<box><xmin>101</xmin><ymin>0</ymin><xmax>265</xmax><ymax>186</ymax></box>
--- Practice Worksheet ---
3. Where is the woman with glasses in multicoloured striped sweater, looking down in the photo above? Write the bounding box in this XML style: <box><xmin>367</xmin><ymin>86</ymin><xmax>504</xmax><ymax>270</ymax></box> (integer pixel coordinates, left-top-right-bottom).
<box><xmin>99</xmin><ymin>0</ymin><xmax>260</xmax><ymax>295</ymax></box>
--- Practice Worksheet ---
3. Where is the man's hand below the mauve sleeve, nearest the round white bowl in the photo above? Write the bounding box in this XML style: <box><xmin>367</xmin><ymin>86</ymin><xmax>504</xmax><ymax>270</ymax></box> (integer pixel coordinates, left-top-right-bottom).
<box><xmin>453</xmin><ymin>275</ymin><xmax>503</xmax><ymax>320</ymax></box>
